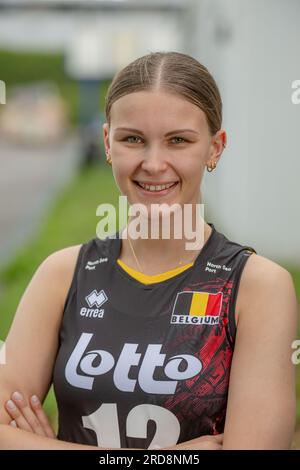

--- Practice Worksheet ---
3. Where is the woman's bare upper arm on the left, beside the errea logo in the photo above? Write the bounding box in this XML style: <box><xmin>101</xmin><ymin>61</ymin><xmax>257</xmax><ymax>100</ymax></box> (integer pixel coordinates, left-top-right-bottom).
<box><xmin>0</xmin><ymin>245</ymin><xmax>80</xmax><ymax>448</ymax></box>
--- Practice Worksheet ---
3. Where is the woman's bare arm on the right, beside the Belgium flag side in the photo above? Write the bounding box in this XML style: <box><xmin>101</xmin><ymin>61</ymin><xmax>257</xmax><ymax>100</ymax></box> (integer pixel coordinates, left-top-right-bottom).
<box><xmin>223</xmin><ymin>255</ymin><xmax>297</xmax><ymax>449</ymax></box>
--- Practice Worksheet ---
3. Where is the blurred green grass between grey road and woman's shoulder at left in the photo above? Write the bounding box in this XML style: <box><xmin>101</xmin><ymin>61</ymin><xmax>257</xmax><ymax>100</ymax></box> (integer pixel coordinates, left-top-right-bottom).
<box><xmin>0</xmin><ymin>165</ymin><xmax>119</xmax><ymax>424</ymax></box>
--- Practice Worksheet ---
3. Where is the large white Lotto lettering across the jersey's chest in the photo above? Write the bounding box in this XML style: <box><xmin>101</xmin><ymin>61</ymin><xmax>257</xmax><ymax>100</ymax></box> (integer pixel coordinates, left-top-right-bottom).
<box><xmin>65</xmin><ymin>333</ymin><xmax>202</xmax><ymax>395</ymax></box>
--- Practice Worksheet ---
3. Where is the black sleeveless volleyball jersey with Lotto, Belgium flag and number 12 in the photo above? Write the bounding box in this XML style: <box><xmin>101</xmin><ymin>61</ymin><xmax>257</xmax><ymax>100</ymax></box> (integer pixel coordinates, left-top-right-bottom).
<box><xmin>53</xmin><ymin>224</ymin><xmax>255</xmax><ymax>449</ymax></box>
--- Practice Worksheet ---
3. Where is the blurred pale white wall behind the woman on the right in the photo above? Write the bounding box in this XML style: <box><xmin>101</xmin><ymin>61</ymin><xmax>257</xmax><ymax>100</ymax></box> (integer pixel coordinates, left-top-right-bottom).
<box><xmin>189</xmin><ymin>0</ymin><xmax>300</xmax><ymax>265</ymax></box>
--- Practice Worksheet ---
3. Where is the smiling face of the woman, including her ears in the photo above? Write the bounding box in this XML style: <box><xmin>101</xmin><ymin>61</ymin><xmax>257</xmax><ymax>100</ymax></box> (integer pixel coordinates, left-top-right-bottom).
<box><xmin>103</xmin><ymin>91</ymin><xmax>226</xmax><ymax>213</ymax></box>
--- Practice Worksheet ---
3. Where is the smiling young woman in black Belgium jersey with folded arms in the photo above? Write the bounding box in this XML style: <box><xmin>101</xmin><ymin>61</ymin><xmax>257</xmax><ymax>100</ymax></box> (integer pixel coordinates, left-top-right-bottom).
<box><xmin>0</xmin><ymin>52</ymin><xmax>297</xmax><ymax>450</ymax></box>
